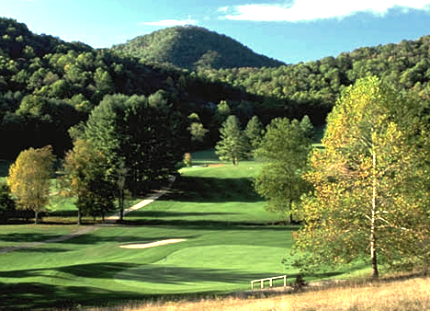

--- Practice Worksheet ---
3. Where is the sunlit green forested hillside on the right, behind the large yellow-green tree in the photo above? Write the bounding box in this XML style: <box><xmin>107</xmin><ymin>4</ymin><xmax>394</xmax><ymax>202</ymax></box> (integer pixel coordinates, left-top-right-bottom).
<box><xmin>198</xmin><ymin>36</ymin><xmax>430</xmax><ymax>123</ymax></box>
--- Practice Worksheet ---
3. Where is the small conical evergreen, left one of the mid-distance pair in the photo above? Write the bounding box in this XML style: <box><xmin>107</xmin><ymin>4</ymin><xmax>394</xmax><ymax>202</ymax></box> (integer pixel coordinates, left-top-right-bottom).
<box><xmin>215</xmin><ymin>115</ymin><xmax>249</xmax><ymax>165</ymax></box>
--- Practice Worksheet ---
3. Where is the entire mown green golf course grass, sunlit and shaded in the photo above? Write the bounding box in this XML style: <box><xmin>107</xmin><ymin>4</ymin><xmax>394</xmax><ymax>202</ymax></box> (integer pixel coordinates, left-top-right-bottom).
<box><xmin>0</xmin><ymin>152</ymin><xmax>362</xmax><ymax>309</ymax></box>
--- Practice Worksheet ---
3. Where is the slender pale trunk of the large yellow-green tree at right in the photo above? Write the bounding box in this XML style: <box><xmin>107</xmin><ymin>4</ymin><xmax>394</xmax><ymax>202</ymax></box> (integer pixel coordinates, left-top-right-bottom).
<box><xmin>369</xmin><ymin>128</ymin><xmax>379</xmax><ymax>279</ymax></box>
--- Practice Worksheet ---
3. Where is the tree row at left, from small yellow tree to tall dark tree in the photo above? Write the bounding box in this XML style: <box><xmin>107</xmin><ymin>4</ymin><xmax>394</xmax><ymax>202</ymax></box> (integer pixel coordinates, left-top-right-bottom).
<box><xmin>0</xmin><ymin>93</ymin><xmax>188</xmax><ymax>224</ymax></box>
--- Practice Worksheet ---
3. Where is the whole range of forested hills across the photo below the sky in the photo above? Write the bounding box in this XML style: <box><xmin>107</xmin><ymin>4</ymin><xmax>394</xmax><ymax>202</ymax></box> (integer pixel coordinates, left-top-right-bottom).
<box><xmin>0</xmin><ymin>18</ymin><xmax>430</xmax><ymax>159</ymax></box>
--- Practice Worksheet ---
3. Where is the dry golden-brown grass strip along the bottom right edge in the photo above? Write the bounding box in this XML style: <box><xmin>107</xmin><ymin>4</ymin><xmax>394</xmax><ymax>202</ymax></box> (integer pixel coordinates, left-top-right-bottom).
<box><xmin>88</xmin><ymin>277</ymin><xmax>430</xmax><ymax>311</ymax></box>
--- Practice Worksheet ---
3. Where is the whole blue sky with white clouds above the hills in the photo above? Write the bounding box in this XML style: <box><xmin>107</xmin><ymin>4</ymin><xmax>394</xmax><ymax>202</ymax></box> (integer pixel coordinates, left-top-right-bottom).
<box><xmin>0</xmin><ymin>0</ymin><xmax>430</xmax><ymax>64</ymax></box>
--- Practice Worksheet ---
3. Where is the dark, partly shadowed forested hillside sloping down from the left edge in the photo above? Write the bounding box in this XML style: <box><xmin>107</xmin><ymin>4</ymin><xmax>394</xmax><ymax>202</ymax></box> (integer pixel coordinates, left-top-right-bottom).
<box><xmin>0</xmin><ymin>18</ymin><xmax>255</xmax><ymax>159</ymax></box>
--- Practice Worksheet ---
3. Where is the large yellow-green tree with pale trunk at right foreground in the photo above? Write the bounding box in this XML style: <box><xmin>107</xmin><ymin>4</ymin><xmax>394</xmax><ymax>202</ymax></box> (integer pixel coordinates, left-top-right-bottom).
<box><xmin>296</xmin><ymin>77</ymin><xmax>430</xmax><ymax>278</ymax></box>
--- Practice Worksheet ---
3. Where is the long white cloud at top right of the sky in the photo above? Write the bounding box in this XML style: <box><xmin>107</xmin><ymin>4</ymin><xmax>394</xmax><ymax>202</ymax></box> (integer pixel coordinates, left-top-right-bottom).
<box><xmin>218</xmin><ymin>0</ymin><xmax>430</xmax><ymax>22</ymax></box>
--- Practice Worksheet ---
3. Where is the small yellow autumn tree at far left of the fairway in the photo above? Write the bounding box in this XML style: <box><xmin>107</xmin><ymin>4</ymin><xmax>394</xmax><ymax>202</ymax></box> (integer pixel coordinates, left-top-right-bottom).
<box><xmin>7</xmin><ymin>146</ymin><xmax>55</xmax><ymax>224</ymax></box>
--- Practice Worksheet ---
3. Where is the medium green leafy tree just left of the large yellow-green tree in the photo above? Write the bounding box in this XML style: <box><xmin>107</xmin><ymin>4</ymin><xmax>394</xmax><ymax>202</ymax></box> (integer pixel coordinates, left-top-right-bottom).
<box><xmin>255</xmin><ymin>118</ymin><xmax>311</xmax><ymax>222</ymax></box>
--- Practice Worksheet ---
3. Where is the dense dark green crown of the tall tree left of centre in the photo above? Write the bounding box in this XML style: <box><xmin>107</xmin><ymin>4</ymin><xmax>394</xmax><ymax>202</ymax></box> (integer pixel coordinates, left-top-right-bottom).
<box><xmin>84</xmin><ymin>93</ymin><xmax>185</xmax><ymax>192</ymax></box>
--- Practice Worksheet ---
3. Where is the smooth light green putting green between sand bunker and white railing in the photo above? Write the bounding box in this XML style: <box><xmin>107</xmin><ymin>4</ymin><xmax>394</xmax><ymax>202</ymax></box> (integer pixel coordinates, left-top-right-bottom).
<box><xmin>114</xmin><ymin>245</ymin><xmax>285</xmax><ymax>293</ymax></box>
